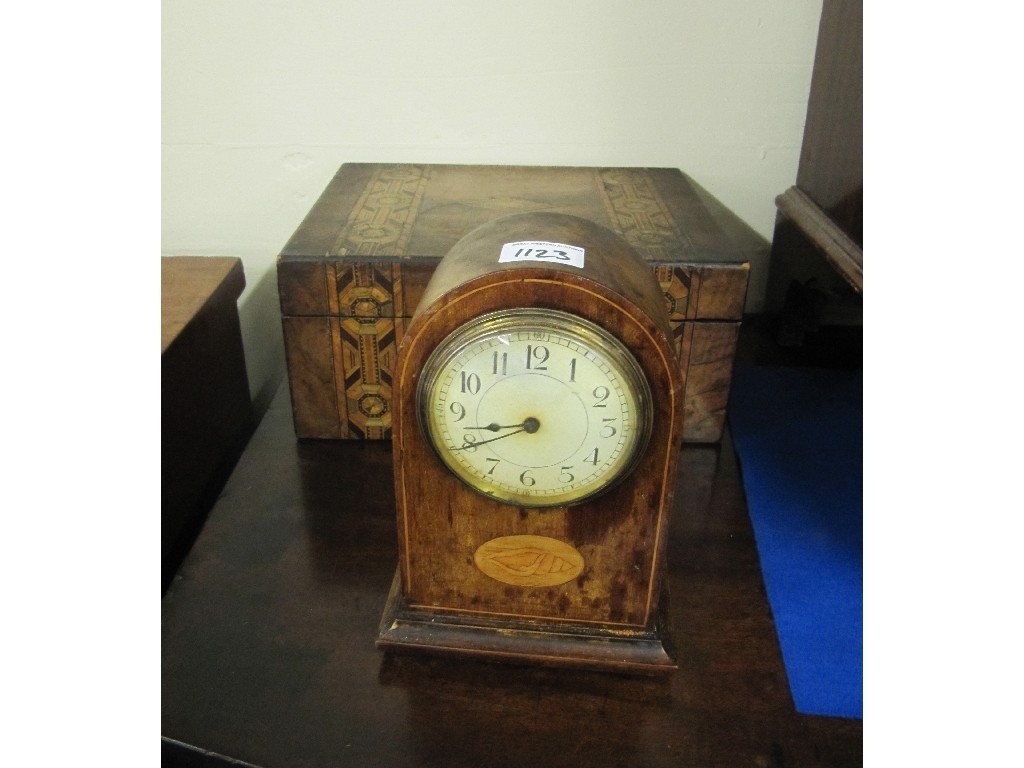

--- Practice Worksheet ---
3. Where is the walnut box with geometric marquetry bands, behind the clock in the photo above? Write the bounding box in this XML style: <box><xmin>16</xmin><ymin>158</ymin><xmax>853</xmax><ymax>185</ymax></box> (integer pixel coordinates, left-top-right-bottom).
<box><xmin>278</xmin><ymin>164</ymin><xmax>767</xmax><ymax>442</ymax></box>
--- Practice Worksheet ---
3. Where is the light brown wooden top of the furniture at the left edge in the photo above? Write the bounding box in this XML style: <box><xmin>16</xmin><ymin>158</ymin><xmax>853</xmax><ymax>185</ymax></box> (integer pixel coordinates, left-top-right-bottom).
<box><xmin>160</xmin><ymin>256</ymin><xmax>246</xmax><ymax>354</ymax></box>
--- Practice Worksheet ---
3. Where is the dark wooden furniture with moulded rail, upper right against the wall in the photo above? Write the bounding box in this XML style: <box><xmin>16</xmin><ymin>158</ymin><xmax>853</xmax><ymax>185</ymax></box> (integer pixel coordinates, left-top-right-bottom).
<box><xmin>766</xmin><ymin>0</ymin><xmax>863</xmax><ymax>346</ymax></box>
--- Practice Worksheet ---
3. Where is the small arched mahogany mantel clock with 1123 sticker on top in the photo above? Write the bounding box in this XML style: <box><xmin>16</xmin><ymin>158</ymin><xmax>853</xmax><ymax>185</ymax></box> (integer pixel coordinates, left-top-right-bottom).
<box><xmin>378</xmin><ymin>213</ymin><xmax>684</xmax><ymax>673</ymax></box>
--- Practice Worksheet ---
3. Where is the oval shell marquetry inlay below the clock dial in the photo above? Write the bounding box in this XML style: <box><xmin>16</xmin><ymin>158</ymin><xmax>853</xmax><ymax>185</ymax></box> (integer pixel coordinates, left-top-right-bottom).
<box><xmin>473</xmin><ymin>536</ymin><xmax>584</xmax><ymax>587</ymax></box>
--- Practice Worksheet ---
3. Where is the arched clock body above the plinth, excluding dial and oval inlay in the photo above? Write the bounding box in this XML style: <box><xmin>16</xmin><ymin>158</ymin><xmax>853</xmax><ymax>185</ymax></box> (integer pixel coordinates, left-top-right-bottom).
<box><xmin>384</xmin><ymin>214</ymin><xmax>683</xmax><ymax>671</ymax></box>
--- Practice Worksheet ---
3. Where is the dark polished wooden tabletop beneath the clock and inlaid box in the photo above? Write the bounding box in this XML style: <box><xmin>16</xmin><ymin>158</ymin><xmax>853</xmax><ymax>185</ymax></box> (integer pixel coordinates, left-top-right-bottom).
<box><xmin>162</xmin><ymin>388</ymin><xmax>862</xmax><ymax>768</ymax></box>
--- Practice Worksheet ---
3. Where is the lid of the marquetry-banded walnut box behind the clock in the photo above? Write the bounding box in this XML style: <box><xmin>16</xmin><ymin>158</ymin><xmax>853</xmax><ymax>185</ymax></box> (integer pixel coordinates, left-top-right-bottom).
<box><xmin>278</xmin><ymin>163</ymin><xmax>767</xmax><ymax>318</ymax></box>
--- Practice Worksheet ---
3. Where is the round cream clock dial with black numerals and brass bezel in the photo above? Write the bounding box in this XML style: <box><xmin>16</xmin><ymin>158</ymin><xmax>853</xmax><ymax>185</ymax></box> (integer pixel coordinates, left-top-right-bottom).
<box><xmin>418</xmin><ymin>309</ymin><xmax>651</xmax><ymax>507</ymax></box>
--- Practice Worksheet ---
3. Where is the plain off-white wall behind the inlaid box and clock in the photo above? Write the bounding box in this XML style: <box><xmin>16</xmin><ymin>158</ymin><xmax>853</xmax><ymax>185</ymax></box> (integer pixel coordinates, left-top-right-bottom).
<box><xmin>162</xmin><ymin>0</ymin><xmax>821</xmax><ymax>415</ymax></box>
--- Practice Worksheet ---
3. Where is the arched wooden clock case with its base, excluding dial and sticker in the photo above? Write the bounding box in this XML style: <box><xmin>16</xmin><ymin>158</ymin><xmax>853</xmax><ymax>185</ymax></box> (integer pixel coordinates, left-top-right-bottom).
<box><xmin>378</xmin><ymin>213</ymin><xmax>683</xmax><ymax>673</ymax></box>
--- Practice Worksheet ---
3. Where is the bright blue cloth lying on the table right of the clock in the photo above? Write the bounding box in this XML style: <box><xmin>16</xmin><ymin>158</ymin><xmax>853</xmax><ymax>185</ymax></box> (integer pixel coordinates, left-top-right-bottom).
<box><xmin>729</xmin><ymin>367</ymin><xmax>863</xmax><ymax>718</ymax></box>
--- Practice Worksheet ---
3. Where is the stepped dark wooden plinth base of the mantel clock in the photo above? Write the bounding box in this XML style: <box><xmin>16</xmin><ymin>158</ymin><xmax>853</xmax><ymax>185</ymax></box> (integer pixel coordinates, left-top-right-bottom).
<box><xmin>377</xmin><ymin>573</ymin><xmax>678</xmax><ymax>675</ymax></box>
